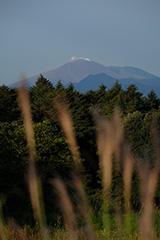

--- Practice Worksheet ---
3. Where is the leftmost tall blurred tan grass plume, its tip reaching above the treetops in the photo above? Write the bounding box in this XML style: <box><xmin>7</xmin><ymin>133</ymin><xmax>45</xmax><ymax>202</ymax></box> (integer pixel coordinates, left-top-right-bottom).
<box><xmin>18</xmin><ymin>83</ymin><xmax>48</xmax><ymax>239</ymax></box>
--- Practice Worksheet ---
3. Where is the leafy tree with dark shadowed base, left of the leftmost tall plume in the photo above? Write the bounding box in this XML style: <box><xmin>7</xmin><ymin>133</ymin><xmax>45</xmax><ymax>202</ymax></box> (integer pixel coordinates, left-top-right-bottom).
<box><xmin>0</xmin><ymin>122</ymin><xmax>29</xmax><ymax>222</ymax></box>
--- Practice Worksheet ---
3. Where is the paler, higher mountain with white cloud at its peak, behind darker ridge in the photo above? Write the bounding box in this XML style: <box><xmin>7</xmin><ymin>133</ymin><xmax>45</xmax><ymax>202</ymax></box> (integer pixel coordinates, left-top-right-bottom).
<box><xmin>9</xmin><ymin>58</ymin><xmax>157</xmax><ymax>87</ymax></box>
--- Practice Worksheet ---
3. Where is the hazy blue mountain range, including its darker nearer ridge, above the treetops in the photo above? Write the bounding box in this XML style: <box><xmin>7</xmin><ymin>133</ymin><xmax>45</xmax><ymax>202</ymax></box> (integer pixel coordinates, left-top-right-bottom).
<box><xmin>9</xmin><ymin>58</ymin><xmax>160</xmax><ymax>96</ymax></box>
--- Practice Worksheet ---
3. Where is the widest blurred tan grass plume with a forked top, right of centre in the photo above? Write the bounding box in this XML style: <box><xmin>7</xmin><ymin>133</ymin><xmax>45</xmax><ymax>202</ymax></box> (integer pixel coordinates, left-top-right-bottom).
<box><xmin>94</xmin><ymin>110</ymin><xmax>122</xmax><ymax>237</ymax></box>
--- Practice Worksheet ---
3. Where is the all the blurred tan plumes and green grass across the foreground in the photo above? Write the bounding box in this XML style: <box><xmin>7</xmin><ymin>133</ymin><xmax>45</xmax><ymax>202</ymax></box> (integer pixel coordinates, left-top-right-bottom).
<box><xmin>0</xmin><ymin>83</ymin><xmax>160</xmax><ymax>240</ymax></box>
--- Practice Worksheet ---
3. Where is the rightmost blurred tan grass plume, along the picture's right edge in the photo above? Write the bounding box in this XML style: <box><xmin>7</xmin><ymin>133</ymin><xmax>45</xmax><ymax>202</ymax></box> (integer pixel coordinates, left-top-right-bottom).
<box><xmin>140</xmin><ymin>122</ymin><xmax>160</xmax><ymax>240</ymax></box>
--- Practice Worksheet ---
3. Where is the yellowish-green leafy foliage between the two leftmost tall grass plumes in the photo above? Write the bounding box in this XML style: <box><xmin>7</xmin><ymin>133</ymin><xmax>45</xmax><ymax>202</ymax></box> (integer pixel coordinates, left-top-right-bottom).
<box><xmin>34</xmin><ymin>120</ymin><xmax>74</xmax><ymax>176</ymax></box>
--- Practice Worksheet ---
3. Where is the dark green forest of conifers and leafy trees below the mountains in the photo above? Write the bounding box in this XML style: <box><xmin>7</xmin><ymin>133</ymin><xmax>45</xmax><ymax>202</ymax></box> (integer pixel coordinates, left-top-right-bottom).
<box><xmin>0</xmin><ymin>75</ymin><xmax>160</xmax><ymax>223</ymax></box>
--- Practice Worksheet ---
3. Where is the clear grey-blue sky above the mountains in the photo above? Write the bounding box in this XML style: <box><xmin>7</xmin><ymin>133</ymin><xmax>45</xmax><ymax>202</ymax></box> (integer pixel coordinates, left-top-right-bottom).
<box><xmin>0</xmin><ymin>0</ymin><xmax>160</xmax><ymax>85</ymax></box>
